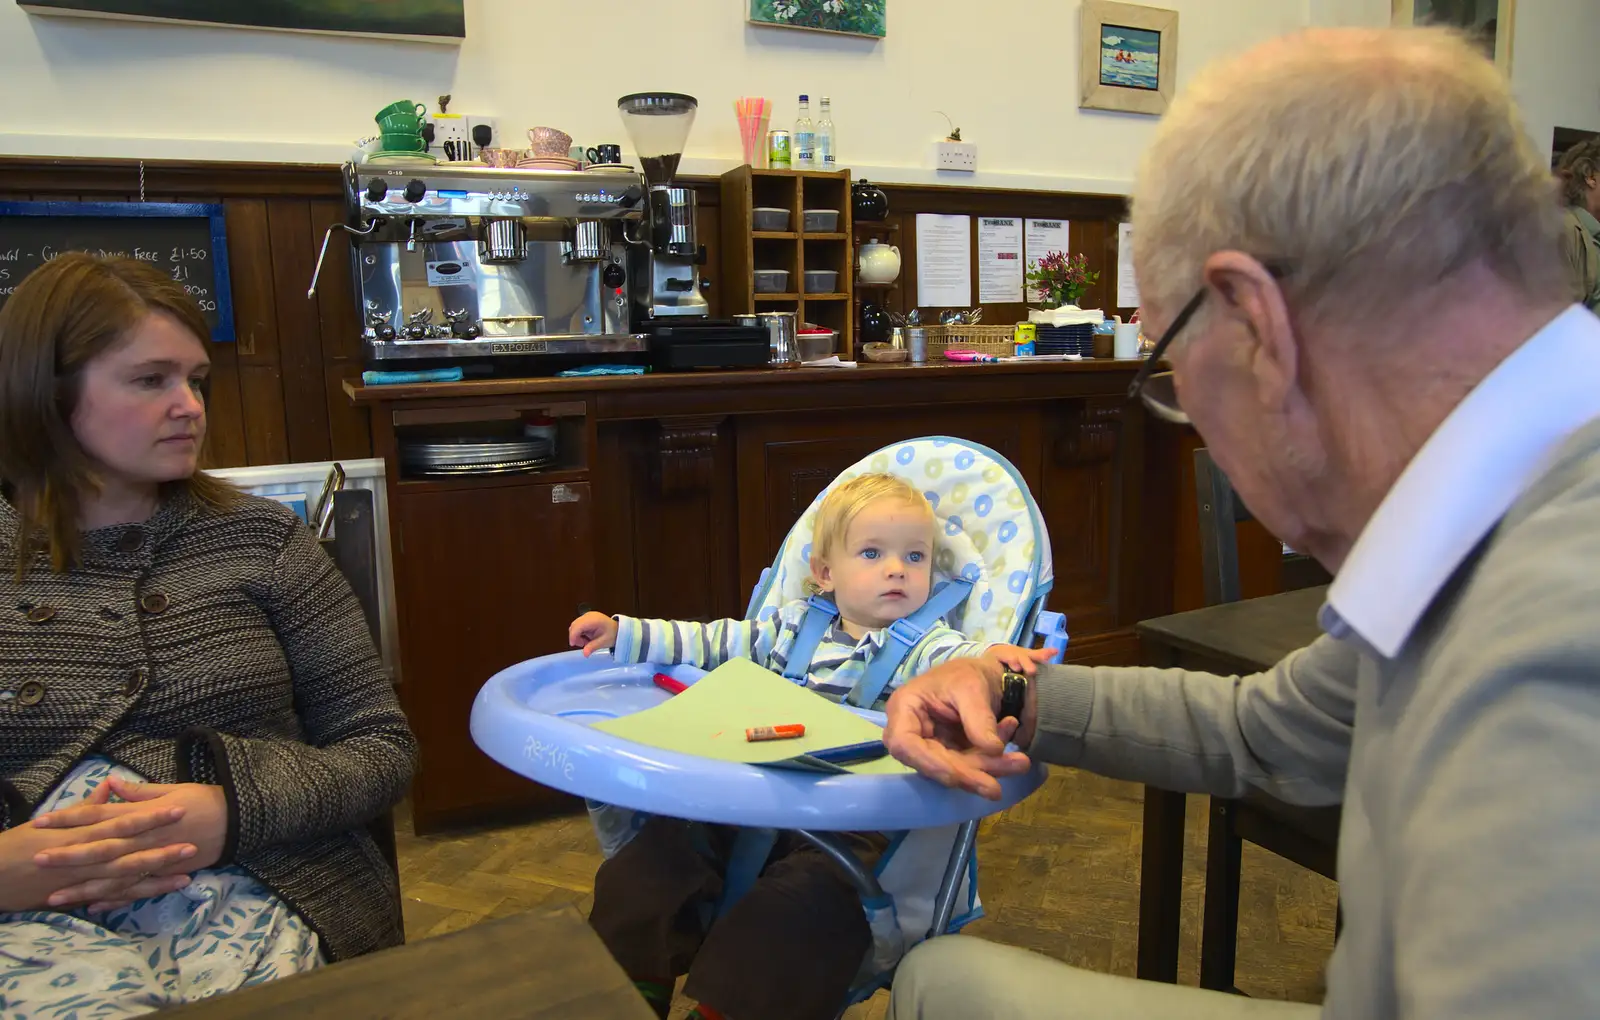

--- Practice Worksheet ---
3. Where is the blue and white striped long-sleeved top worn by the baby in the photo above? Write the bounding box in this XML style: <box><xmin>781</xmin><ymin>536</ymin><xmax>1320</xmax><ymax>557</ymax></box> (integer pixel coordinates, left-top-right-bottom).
<box><xmin>613</xmin><ymin>598</ymin><xmax>992</xmax><ymax>708</ymax></box>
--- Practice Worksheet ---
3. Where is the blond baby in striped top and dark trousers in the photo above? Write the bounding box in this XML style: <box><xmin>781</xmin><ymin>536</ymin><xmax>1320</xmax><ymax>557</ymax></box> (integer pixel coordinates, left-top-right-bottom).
<box><xmin>568</xmin><ymin>475</ymin><xmax>1050</xmax><ymax>1020</ymax></box>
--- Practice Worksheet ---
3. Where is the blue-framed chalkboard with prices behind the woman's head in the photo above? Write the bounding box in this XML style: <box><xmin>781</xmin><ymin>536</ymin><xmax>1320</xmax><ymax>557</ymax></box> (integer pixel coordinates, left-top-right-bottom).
<box><xmin>0</xmin><ymin>201</ymin><xmax>234</xmax><ymax>342</ymax></box>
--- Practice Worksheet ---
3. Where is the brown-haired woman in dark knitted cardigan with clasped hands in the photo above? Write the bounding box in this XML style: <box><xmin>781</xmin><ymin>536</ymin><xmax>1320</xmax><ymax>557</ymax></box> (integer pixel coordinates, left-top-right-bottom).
<box><xmin>0</xmin><ymin>254</ymin><xmax>416</xmax><ymax>1017</ymax></box>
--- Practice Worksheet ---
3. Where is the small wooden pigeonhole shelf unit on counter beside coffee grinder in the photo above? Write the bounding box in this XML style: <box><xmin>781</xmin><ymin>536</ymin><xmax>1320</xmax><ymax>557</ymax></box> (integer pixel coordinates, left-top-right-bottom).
<box><xmin>722</xmin><ymin>166</ymin><xmax>856</xmax><ymax>358</ymax></box>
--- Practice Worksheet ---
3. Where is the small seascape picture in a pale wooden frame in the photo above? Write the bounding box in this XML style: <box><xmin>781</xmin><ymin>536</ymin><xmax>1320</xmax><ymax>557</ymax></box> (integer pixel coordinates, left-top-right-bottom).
<box><xmin>1078</xmin><ymin>0</ymin><xmax>1178</xmax><ymax>115</ymax></box>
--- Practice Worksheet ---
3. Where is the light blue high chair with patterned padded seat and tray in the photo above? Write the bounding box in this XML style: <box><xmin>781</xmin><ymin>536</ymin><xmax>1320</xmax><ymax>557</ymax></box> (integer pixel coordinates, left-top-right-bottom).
<box><xmin>472</xmin><ymin>436</ymin><xmax>1067</xmax><ymax>1007</ymax></box>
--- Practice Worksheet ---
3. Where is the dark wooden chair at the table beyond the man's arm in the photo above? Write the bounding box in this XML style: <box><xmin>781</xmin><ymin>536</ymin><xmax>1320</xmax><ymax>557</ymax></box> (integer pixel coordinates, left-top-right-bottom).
<box><xmin>1195</xmin><ymin>448</ymin><xmax>1341</xmax><ymax>991</ymax></box>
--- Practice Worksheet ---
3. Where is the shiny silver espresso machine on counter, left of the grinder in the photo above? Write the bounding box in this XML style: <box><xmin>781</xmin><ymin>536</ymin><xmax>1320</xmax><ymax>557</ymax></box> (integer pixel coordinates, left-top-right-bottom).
<box><xmin>309</xmin><ymin>160</ymin><xmax>650</xmax><ymax>369</ymax></box>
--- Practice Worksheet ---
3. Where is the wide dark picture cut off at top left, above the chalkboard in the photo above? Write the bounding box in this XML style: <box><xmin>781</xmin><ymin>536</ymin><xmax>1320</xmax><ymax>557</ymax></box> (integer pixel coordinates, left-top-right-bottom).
<box><xmin>16</xmin><ymin>0</ymin><xmax>467</xmax><ymax>43</ymax></box>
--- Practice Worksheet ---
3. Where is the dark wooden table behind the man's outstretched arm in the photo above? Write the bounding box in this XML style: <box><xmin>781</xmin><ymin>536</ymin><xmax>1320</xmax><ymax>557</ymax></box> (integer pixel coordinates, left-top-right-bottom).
<box><xmin>1136</xmin><ymin>585</ymin><xmax>1328</xmax><ymax>982</ymax></box>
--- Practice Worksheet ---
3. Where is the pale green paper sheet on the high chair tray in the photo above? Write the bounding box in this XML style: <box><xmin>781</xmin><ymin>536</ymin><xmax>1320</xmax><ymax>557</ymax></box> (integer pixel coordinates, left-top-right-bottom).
<box><xmin>594</xmin><ymin>659</ymin><xmax>910</xmax><ymax>775</ymax></box>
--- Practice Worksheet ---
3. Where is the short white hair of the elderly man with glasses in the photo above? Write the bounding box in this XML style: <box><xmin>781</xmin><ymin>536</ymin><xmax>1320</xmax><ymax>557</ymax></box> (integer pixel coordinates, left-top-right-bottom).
<box><xmin>1133</xmin><ymin>29</ymin><xmax>1566</xmax><ymax>321</ymax></box>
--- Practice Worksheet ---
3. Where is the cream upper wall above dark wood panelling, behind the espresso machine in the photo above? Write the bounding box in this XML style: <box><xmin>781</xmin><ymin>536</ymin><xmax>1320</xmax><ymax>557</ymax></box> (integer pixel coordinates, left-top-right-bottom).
<box><xmin>0</xmin><ymin>0</ymin><xmax>1312</xmax><ymax>192</ymax></box>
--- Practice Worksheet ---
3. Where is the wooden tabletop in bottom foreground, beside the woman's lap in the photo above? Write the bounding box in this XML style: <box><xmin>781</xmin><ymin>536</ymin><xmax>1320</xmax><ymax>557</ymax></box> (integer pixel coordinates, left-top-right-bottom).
<box><xmin>166</xmin><ymin>906</ymin><xmax>654</xmax><ymax>1020</ymax></box>
